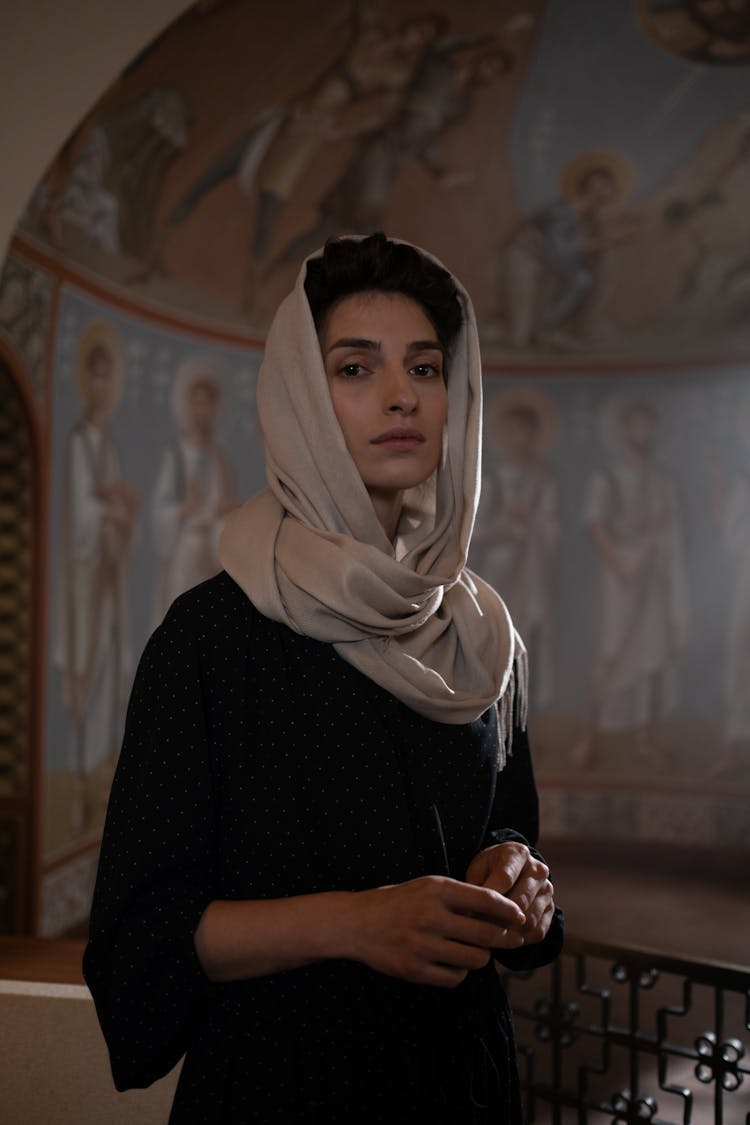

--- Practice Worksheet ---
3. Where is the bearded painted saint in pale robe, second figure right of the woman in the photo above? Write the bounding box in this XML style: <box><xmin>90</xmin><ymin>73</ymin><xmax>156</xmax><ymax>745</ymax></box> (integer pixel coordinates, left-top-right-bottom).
<box><xmin>575</xmin><ymin>399</ymin><xmax>690</xmax><ymax>765</ymax></box>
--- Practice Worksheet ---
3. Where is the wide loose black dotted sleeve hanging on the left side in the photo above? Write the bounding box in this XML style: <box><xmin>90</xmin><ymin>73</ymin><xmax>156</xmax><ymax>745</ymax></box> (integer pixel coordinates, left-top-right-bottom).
<box><xmin>83</xmin><ymin>603</ymin><xmax>217</xmax><ymax>1090</ymax></box>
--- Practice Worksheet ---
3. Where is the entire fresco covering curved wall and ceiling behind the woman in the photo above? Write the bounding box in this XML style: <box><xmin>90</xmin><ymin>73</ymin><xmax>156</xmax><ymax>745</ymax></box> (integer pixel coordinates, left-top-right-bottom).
<box><xmin>5</xmin><ymin>0</ymin><xmax>750</xmax><ymax>934</ymax></box>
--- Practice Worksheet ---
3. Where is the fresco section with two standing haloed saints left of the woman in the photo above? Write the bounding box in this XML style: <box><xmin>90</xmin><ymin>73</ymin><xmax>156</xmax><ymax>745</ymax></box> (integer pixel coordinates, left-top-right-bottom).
<box><xmin>45</xmin><ymin>286</ymin><xmax>263</xmax><ymax>857</ymax></box>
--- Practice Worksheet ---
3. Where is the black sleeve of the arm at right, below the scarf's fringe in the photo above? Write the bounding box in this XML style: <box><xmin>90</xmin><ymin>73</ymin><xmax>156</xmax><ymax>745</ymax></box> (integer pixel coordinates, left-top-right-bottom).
<box><xmin>484</xmin><ymin>727</ymin><xmax>563</xmax><ymax>972</ymax></box>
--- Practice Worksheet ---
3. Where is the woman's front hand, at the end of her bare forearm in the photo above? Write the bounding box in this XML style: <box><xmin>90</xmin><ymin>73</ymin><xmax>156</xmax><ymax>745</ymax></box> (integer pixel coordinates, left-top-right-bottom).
<box><xmin>345</xmin><ymin>875</ymin><xmax>526</xmax><ymax>988</ymax></box>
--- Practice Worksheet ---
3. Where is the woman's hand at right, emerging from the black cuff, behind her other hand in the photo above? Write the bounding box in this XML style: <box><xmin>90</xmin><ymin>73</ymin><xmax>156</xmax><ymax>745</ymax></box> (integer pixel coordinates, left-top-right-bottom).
<box><xmin>467</xmin><ymin>842</ymin><xmax>554</xmax><ymax>950</ymax></box>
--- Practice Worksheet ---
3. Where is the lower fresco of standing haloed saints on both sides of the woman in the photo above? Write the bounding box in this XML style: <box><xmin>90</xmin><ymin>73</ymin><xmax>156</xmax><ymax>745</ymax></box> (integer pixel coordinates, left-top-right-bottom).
<box><xmin>39</xmin><ymin>285</ymin><xmax>750</xmax><ymax>873</ymax></box>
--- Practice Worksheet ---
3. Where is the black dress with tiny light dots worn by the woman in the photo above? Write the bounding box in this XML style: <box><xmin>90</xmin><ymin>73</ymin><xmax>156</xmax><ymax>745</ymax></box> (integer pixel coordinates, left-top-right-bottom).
<box><xmin>84</xmin><ymin>574</ymin><xmax>562</xmax><ymax>1125</ymax></box>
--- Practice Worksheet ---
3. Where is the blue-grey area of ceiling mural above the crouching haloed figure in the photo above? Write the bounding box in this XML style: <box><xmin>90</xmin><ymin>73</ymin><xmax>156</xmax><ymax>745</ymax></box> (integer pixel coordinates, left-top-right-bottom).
<box><xmin>509</xmin><ymin>0</ymin><xmax>750</xmax><ymax>204</ymax></box>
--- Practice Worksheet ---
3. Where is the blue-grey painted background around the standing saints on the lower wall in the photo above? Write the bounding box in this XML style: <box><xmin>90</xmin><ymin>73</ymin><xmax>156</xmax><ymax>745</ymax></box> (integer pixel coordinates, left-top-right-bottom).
<box><xmin>47</xmin><ymin>288</ymin><xmax>750</xmax><ymax>805</ymax></box>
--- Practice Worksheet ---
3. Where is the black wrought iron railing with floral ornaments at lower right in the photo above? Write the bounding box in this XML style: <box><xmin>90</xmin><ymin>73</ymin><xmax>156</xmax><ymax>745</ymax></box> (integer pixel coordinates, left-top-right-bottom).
<box><xmin>504</xmin><ymin>935</ymin><xmax>750</xmax><ymax>1125</ymax></box>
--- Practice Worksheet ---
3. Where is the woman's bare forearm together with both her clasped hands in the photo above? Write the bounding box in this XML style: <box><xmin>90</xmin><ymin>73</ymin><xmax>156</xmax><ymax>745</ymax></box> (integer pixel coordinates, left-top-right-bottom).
<box><xmin>195</xmin><ymin>844</ymin><xmax>552</xmax><ymax>988</ymax></box>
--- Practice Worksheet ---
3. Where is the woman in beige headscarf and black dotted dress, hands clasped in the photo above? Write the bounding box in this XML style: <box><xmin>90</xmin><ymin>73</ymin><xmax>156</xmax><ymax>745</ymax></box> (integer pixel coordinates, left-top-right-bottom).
<box><xmin>84</xmin><ymin>235</ymin><xmax>561</xmax><ymax>1125</ymax></box>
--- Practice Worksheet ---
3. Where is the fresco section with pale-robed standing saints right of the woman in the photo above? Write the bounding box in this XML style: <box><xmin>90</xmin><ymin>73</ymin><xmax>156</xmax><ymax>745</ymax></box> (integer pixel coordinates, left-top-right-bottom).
<box><xmin>471</xmin><ymin>369</ymin><xmax>750</xmax><ymax>786</ymax></box>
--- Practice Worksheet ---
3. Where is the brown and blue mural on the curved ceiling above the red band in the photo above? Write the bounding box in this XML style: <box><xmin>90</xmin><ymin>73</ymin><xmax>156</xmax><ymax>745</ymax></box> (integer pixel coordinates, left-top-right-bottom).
<box><xmin>22</xmin><ymin>0</ymin><xmax>750</xmax><ymax>366</ymax></box>
